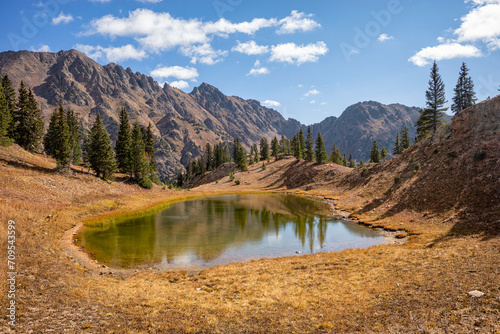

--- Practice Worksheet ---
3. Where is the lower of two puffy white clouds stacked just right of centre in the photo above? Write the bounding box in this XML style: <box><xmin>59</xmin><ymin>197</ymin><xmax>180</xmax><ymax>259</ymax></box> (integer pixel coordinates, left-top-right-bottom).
<box><xmin>269</xmin><ymin>42</ymin><xmax>328</xmax><ymax>65</ymax></box>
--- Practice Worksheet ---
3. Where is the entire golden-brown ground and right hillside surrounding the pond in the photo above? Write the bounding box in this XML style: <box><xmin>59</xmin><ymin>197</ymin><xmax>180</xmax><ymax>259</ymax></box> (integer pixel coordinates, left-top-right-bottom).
<box><xmin>0</xmin><ymin>98</ymin><xmax>500</xmax><ymax>333</ymax></box>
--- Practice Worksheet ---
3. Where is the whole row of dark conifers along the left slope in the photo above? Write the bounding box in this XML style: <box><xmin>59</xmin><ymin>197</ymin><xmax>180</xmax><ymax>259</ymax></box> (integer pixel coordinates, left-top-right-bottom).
<box><xmin>0</xmin><ymin>75</ymin><xmax>156</xmax><ymax>188</ymax></box>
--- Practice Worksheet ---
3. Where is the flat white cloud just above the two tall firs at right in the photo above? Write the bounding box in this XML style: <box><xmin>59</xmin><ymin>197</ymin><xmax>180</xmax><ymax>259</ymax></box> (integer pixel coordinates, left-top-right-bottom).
<box><xmin>409</xmin><ymin>43</ymin><xmax>482</xmax><ymax>67</ymax></box>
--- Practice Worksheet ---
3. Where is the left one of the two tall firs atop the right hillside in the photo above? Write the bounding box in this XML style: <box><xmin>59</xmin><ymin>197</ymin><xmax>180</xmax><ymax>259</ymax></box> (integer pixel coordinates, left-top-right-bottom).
<box><xmin>416</xmin><ymin>62</ymin><xmax>448</xmax><ymax>139</ymax></box>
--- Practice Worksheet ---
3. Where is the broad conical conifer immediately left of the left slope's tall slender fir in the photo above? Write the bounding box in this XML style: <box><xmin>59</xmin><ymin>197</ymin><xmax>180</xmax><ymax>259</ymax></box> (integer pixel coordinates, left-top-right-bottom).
<box><xmin>87</xmin><ymin>114</ymin><xmax>116</xmax><ymax>179</ymax></box>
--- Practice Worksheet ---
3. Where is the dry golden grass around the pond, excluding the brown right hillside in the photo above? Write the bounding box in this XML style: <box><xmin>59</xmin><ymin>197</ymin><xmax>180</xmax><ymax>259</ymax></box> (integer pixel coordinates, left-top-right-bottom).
<box><xmin>0</xmin><ymin>148</ymin><xmax>500</xmax><ymax>333</ymax></box>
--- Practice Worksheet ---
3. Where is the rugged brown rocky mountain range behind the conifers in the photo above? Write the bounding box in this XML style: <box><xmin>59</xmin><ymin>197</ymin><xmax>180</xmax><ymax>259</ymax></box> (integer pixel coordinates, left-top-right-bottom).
<box><xmin>0</xmin><ymin>50</ymin><xmax>419</xmax><ymax>177</ymax></box>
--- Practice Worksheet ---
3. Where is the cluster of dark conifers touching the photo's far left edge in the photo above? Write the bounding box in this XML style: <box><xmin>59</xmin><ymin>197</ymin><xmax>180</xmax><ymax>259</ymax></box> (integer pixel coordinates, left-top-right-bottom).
<box><xmin>0</xmin><ymin>75</ymin><xmax>43</xmax><ymax>152</ymax></box>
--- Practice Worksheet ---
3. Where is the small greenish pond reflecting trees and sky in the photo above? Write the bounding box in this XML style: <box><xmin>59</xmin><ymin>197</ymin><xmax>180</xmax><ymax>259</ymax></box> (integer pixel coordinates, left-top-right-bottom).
<box><xmin>75</xmin><ymin>194</ymin><xmax>386</xmax><ymax>269</ymax></box>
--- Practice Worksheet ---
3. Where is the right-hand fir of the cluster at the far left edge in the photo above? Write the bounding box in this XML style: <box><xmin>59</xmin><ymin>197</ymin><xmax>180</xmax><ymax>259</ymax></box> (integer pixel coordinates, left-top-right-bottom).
<box><xmin>13</xmin><ymin>81</ymin><xmax>43</xmax><ymax>152</ymax></box>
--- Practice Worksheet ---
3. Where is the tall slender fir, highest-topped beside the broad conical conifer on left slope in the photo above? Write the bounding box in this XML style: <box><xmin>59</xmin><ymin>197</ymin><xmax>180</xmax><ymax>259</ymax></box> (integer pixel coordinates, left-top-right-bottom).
<box><xmin>115</xmin><ymin>107</ymin><xmax>132</xmax><ymax>175</ymax></box>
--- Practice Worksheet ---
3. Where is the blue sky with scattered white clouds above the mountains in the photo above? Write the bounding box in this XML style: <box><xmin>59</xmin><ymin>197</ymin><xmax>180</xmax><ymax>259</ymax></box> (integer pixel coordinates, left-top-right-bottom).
<box><xmin>0</xmin><ymin>0</ymin><xmax>500</xmax><ymax>124</ymax></box>
